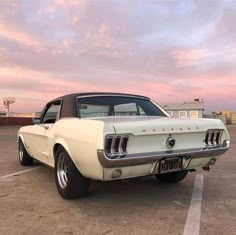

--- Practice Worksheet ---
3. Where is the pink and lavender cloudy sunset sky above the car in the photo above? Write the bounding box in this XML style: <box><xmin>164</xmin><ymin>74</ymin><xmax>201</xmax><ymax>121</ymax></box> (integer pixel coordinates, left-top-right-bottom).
<box><xmin>0</xmin><ymin>0</ymin><xmax>236</xmax><ymax>112</ymax></box>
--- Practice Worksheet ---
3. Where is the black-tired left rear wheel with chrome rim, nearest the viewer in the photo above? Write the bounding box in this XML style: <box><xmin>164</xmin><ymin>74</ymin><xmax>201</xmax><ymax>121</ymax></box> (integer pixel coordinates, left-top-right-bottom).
<box><xmin>54</xmin><ymin>147</ymin><xmax>90</xmax><ymax>199</ymax></box>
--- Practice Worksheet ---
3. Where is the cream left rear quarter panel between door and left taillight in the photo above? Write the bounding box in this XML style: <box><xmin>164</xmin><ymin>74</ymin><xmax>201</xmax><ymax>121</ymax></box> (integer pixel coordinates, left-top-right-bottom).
<box><xmin>54</xmin><ymin>118</ymin><xmax>114</xmax><ymax>180</ymax></box>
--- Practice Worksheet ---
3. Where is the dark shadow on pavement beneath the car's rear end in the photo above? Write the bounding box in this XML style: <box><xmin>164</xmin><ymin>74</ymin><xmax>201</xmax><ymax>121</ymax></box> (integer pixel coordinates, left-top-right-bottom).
<box><xmin>71</xmin><ymin>174</ymin><xmax>195</xmax><ymax>207</ymax></box>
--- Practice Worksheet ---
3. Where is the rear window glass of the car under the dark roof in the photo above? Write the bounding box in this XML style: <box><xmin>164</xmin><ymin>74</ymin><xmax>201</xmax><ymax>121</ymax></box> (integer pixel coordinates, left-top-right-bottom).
<box><xmin>77</xmin><ymin>96</ymin><xmax>166</xmax><ymax>118</ymax></box>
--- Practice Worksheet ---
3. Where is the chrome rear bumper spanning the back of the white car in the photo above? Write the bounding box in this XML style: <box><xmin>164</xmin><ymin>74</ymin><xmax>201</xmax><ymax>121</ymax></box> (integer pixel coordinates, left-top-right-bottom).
<box><xmin>97</xmin><ymin>145</ymin><xmax>229</xmax><ymax>168</ymax></box>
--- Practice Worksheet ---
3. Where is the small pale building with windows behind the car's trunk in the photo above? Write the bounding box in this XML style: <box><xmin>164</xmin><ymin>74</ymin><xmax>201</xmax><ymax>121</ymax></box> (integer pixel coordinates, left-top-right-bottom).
<box><xmin>162</xmin><ymin>99</ymin><xmax>205</xmax><ymax>118</ymax></box>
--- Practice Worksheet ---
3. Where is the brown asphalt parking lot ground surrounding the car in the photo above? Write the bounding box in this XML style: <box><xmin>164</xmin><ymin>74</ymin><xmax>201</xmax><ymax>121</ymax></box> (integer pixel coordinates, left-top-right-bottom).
<box><xmin>0</xmin><ymin>126</ymin><xmax>236</xmax><ymax>235</ymax></box>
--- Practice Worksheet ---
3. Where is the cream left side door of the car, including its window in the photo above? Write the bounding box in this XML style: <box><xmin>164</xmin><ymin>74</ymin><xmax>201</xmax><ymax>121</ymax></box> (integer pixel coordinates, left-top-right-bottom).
<box><xmin>27</xmin><ymin>100</ymin><xmax>61</xmax><ymax>163</ymax></box>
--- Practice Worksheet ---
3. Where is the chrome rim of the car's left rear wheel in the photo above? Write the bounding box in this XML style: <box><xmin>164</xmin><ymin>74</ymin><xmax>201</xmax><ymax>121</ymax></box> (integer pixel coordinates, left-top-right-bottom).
<box><xmin>56</xmin><ymin>153</ymin><xmax>68</xmax><ymax>189</ymax></box>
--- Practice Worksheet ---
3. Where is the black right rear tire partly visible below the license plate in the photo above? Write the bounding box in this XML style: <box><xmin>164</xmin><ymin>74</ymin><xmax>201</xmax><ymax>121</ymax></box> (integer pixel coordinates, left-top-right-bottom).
<box><xmin>156</xmin><ymin>171</ymin><xmax>188</xmax><ymax>184</ymax></box>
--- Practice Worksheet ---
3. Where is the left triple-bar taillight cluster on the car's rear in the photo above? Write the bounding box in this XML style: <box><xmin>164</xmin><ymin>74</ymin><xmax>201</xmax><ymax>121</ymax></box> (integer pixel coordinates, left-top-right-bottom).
<box><xmin>105</xmin><ymin>135</ymin><xmax>128</xmax><ymax>158</ymax></box>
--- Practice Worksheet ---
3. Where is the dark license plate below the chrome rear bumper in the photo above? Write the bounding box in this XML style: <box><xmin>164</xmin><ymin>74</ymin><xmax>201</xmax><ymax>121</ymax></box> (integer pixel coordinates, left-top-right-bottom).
<box><xmin>159</xmin><ymin>157</ymin><xmax>183</xmax><ymax>173</ymax></box>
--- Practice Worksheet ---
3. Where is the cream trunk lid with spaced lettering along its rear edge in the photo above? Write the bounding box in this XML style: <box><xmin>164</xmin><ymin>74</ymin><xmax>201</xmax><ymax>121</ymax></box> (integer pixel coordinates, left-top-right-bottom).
<box><xmin>89</xmin><ymin>116</ymin><xmax>225</xmax><ymax>136</ymax></box>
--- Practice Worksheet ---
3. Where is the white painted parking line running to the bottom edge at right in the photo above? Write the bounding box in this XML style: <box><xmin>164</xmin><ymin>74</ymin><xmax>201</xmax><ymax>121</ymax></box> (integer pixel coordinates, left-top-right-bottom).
<box><xmin>183</xmin><ymin>174</ymin><xmax>204</xmax><ymax>235</ymax></box>
